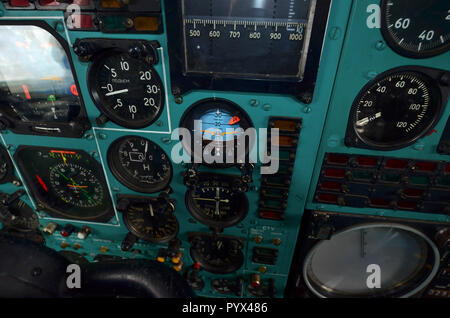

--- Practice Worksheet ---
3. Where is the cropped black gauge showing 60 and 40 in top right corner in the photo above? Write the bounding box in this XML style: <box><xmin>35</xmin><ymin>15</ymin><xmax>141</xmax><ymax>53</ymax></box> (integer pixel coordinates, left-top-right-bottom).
<box><xmin>381</xmin><ymin>0</ymin><xmax>450</xmax><ymax>58</ymax></box>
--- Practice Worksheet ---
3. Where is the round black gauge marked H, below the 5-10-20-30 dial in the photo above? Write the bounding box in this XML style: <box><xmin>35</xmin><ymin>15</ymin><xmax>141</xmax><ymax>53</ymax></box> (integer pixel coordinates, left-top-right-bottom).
<box><xmin>108</xmin><ymin>136</ymin><xmax>173</xmax><ymax>193</ymax></box>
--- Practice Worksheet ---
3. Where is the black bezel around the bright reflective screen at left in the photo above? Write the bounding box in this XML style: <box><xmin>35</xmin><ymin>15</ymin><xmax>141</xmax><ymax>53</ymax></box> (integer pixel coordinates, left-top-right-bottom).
<box><xmin>0</xmin><ymin>20</ymin><xmax>92</xmax><ymax>138</ymax></box>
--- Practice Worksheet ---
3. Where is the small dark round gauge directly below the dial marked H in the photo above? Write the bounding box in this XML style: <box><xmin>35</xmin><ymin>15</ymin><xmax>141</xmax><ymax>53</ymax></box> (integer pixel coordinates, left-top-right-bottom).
<box><xmin>123</xmin><ymin>201</ymin><xmax>179</xmax><ymax>243</ymax></box>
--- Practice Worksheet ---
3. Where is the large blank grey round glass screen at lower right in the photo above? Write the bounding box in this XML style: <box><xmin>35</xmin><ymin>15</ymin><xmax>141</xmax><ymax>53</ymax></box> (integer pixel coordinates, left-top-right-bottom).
<box><xmin>303</xmin><ymin>223</ymin><xmax>439</xmax><ymax>297</ymax></box>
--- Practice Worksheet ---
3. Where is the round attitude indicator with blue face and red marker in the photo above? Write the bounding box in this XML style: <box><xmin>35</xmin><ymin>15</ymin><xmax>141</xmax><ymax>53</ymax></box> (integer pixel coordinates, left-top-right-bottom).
<box><xmin>180</xmin><ymin>98</ymin><xmax>253</xmax><ymax>167</ymax></box>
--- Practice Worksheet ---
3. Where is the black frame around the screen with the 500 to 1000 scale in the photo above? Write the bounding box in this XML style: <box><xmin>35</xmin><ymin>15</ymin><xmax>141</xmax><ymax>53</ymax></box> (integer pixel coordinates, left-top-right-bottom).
<box><xmin>165</xmin><ymin>0</ymin><xmax>331</xmax><ymax>104</ymax></box>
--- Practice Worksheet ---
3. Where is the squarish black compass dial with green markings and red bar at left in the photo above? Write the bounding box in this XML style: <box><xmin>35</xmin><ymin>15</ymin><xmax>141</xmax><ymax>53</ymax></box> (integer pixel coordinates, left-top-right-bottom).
<box><xmin>15</xmin><ymin>146</ymin><xmax>114</xmax><ymax>222</ymax></box>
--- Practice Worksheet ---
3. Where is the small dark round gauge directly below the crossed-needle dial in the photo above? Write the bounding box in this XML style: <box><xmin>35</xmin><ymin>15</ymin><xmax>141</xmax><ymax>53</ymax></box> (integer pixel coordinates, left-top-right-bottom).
<box><xmin>190</xmin><ymin>235</ymin><xmax>244</xmax><ymax>274</ymax></box>
